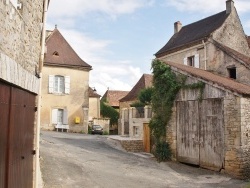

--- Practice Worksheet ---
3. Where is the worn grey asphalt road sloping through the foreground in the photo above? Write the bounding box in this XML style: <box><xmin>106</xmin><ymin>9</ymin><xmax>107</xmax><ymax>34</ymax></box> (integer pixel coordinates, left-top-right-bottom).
<box><xmin>40</xmin><ymin>131</ymin><xmax>250</xmax><ymax>188</ymax></box>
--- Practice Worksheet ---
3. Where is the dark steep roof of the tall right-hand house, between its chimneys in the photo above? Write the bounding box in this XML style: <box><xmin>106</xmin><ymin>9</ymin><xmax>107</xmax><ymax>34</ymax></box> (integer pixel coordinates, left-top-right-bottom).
<box><xmin>155</xmin><ymin>11</ymin><xmax>228</xmax><ymax>57</ymax></box>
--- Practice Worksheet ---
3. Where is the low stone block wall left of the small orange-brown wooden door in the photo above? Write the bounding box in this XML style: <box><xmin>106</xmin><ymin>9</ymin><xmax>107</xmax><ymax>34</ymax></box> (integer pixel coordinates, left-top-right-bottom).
<box><xmin>120</xmin><ymin>140</ymin><xmax>143</xmax><ymax>152</ymax></box>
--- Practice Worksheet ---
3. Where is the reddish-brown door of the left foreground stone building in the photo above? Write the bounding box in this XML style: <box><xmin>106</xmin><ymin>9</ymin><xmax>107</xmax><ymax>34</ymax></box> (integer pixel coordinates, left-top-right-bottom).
<box><xmin>0</xmin><ymin>82</ymin><xmax>36</xmax><ymax>188</ymax></box>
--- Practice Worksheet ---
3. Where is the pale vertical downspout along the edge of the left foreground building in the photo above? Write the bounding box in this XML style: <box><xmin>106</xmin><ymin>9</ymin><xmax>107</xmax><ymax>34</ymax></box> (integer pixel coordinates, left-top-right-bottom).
<box><xmin>35</xmin><ymin>0</ymin><xmax>48</xmax><ymax>188</ymax></box>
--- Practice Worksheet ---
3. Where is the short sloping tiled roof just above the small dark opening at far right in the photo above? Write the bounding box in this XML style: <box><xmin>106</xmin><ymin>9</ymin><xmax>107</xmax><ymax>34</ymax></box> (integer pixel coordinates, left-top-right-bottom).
<box><xmin>213</xmin><ymin>41</ymin><xmax>250</xmax><ymax>68</ymax></box>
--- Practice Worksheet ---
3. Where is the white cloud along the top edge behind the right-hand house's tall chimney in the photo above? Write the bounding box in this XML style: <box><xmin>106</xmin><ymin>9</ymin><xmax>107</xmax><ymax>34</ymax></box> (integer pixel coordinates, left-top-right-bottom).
<box><xmin>166</xmin><ymin>0</ymin><xmax>250</xmax><ymax>13</ymax></box>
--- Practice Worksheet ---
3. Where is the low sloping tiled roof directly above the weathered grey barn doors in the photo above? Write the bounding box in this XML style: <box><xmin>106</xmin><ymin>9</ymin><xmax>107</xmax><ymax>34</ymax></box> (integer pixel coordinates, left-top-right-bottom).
<box><xmin>165</xmin><ymin>62</ymin><xmax>250</xmax><ymax>97</ymax></box>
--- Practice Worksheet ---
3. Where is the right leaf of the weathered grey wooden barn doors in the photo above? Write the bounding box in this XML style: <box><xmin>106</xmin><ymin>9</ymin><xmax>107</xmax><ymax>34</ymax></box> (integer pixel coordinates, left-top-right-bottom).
<box><xmin>200</xmin><ymin>99</ymin><xmax>224</xmax><ymax>171</ymax></box>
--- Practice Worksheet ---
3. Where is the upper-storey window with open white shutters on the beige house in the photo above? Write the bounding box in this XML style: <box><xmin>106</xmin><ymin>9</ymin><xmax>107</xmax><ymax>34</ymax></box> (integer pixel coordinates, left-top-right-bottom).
<box><xmin>49</xmin><ymin>75</ymin><xmax>70</xmax><ymax>94</ymax></box>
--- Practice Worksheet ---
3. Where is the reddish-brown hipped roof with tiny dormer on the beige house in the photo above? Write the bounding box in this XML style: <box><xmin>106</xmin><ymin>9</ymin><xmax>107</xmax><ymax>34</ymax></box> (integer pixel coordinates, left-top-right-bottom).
<box><xmin>44</xmin><ymin>29</ymin><xmax>92</xmax><ymax>70</ymax></box>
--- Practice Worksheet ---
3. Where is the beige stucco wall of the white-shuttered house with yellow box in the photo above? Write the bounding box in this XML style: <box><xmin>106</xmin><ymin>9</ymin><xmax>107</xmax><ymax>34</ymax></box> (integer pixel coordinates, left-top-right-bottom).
<box><xmin>41</xmin><ymin>66</ymin><xmax>89</xmax><ymax>133</ymax></box>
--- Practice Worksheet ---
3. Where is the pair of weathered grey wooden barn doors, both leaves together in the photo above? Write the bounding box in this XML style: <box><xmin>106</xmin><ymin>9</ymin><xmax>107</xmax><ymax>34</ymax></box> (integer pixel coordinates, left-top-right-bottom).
<box><xmin>176</xmin><ymin>99</ymin><xmax>224</xmax><ymax>170</ymax></box>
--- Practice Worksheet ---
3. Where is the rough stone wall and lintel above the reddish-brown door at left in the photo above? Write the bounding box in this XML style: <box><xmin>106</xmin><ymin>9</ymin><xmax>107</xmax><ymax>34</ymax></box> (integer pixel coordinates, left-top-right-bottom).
<box><xmin>0</xmin><ymin>0</ymin><xmax>43</xmax><ymax>93</ymax></box>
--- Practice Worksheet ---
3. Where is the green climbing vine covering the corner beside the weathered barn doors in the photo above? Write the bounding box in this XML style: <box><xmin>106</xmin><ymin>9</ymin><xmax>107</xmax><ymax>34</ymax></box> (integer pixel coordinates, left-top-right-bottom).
<box><xmin>149</xmin><ymin>60</ymin><xmax>205</xmax><ymax>161</ymax></box>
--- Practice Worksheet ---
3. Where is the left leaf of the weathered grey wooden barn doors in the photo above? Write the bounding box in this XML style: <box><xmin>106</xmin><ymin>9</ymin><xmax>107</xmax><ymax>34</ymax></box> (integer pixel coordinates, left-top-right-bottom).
<box><xmin>176</xmin><ymin>101</ymin><xmax>199</xmax><ymax>165</ymax></box>
